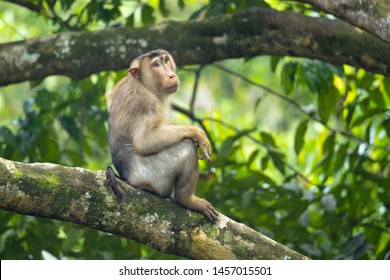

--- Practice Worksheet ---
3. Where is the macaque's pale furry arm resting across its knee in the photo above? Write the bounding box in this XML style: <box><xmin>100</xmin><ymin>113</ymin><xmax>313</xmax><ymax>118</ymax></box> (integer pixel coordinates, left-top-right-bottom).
<box><xmin>133</xmin><ymin>121</ymin><xmax>211</xmax><ymax>161</ymax></box>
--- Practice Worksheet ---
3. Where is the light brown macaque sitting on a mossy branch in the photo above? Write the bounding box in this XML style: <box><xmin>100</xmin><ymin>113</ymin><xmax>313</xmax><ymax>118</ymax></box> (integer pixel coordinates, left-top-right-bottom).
<box><xmin>107</xmin><ymin>50</ymin><xmax>218</xmax><ymax>221</ymax></box>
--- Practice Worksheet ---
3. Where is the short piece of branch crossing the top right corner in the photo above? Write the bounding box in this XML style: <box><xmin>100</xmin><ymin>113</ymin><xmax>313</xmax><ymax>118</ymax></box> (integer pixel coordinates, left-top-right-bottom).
<box><xmin>300</xmin><ymin>0</ymin><xmax>390</xmax><ymax>43</ymax></box>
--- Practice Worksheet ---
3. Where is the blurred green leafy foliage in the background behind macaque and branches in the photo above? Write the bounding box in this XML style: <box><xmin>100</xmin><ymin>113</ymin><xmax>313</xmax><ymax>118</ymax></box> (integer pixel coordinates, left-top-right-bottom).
<box><xmin>0</xmin><ymin>0</ymin><xmax>390</xmax><ymax>259</ymax></box>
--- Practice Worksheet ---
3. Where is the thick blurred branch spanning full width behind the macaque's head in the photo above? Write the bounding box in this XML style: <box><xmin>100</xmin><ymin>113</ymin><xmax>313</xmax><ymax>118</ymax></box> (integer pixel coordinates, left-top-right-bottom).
<box><xmin>0</xmin><ymin>8</ymin><xmax>390</xmax><ymax>85</ymax></box>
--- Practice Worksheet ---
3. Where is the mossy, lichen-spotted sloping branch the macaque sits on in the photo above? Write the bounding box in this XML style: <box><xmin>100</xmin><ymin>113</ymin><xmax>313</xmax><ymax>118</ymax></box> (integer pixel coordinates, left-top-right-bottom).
<box><xmin>0</xmin><ymin>158</ymin><xmax>308</xmax><ymax>259</ymax></box>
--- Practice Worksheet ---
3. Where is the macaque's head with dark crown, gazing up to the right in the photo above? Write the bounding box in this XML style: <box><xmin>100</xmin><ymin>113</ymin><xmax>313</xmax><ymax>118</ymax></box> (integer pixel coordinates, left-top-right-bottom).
<box><xmin>129</xmin><ymin>50</ymin><xmax>180</xmax><ymax>96</ymax></box>
